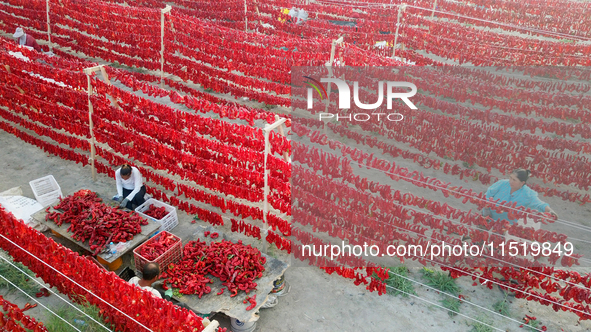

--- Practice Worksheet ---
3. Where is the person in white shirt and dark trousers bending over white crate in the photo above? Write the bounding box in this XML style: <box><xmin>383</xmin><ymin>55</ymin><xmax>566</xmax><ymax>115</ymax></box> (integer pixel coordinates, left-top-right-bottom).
<box><xmin>113</xmin><ymin>164</ymin><xmax>146</xmax><ymax>210</ymax></box>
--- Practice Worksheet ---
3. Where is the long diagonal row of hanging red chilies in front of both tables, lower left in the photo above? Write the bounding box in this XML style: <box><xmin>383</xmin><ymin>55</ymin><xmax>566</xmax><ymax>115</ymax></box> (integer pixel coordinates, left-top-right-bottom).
<box><xmin>0</xmin><ymin>208</ymin><xmax>203</xmax><ymax>332</ymax></box>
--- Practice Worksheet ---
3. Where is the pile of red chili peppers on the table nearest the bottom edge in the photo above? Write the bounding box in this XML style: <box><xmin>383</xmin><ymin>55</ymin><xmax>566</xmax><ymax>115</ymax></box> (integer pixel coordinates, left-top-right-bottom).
<box><xmin>162</xmin><ymin>239</ymin><xmax>266</xmax><ymax>298</ymax></box>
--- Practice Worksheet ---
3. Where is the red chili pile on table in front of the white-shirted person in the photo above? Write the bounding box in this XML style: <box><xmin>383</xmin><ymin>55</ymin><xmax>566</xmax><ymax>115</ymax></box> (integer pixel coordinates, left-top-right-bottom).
<box><xmin>45</xmin><ymin>190</ymin><xmax>148</xmax><ymax>255</ymax></box>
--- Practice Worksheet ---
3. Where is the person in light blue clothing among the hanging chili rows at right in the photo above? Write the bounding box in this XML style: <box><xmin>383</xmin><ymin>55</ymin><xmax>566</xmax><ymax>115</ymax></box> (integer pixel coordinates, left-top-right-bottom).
<box><xmin>482</xmin><ymin>169</ymin><xmax>558</xmax><ymax>224</ymax></box>
